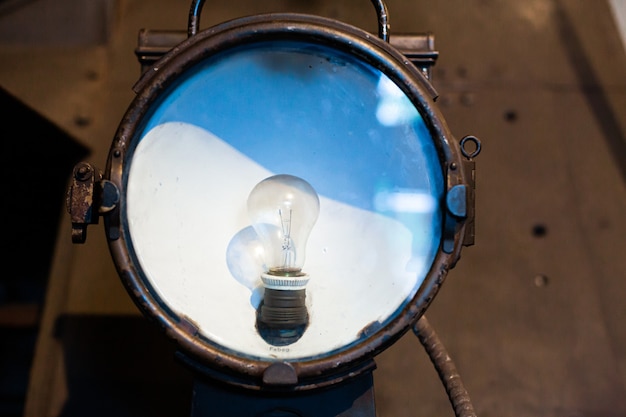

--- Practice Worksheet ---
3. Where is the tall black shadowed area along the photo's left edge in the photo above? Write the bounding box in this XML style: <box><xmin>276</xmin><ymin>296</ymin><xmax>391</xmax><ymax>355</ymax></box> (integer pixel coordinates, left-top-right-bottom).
<box><xmin>0</xmin><ymin>87</ymin><xmax>89</xmax><ymax>417</ymax></box>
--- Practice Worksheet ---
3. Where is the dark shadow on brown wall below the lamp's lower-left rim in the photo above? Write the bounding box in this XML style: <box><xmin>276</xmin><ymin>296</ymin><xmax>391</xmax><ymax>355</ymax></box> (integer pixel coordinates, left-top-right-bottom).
<box><xmin>55</xmin><ymin>315</ymin><xmax>193</xmax><ymax>417</ymax></box>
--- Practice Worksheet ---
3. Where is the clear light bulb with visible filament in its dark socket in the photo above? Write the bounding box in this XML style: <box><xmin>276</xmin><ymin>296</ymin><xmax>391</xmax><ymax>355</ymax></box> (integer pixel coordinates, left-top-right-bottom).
<box><xmin>248</xmin><ymin>174</ymin><xmax>320</xmax><ymax>330</ymax></box>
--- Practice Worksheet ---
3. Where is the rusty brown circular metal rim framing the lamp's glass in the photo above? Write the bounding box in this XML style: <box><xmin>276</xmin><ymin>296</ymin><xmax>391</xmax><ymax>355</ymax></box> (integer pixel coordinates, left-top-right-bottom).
<box><xmin>105</xmin><ymin>14</ymin><xmax>468</xmax><ymax>390</ymax></box>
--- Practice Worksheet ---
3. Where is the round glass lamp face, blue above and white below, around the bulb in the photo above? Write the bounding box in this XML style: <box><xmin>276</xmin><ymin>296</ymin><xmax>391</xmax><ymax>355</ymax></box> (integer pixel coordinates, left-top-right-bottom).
<box><xmin>123</xmin><ymin>42</ymin><xmax>443</xmax><ymax>360</ymax></box>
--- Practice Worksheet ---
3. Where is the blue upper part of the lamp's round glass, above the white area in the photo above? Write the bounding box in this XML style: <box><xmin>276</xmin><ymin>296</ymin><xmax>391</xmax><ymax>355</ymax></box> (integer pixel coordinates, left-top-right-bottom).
<box><xmin>141</xmin><ymin>42</ymin><xmax>443</xmax><ymax>259</ymax></box>
